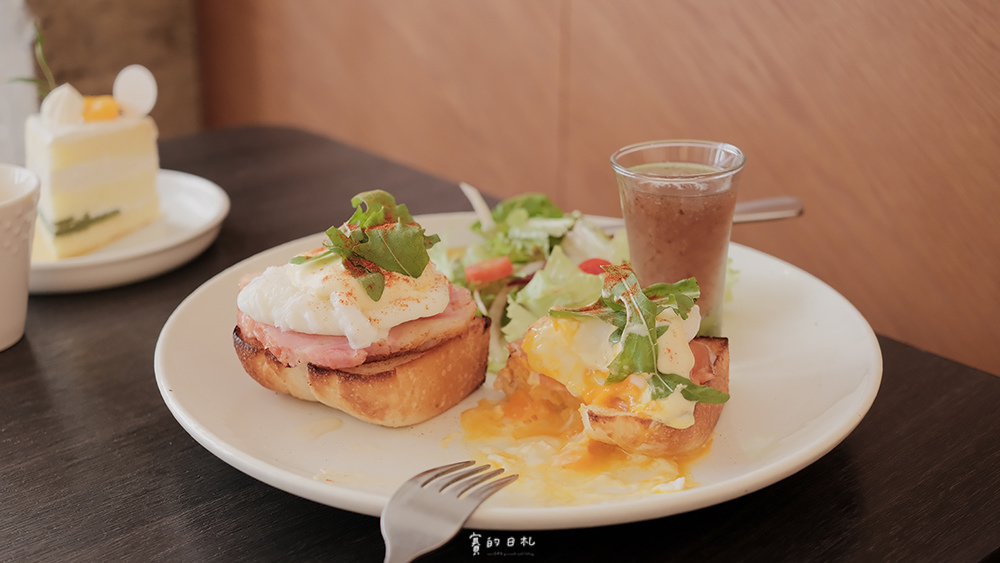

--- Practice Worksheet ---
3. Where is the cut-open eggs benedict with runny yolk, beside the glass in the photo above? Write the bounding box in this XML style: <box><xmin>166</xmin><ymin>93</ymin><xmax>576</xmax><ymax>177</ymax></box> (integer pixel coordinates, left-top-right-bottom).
<box><xmin>480</xmin><ymin>264</ymin><xmax>729</xmax><ymax>457</ymax></box>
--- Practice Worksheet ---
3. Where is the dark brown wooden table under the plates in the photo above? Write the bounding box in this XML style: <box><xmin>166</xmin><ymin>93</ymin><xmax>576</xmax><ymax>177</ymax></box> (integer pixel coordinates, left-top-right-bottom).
<box><xmin>0</xmin><ymin>128</ymin><xmax>1000</xmax><ymax>562</ymax></box>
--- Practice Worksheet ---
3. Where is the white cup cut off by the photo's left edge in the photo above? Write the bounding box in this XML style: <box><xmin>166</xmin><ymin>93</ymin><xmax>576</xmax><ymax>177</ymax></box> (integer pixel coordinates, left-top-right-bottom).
<box><xmin>0</xmin><ymin>164</ymin><xmax>38</xmax><ymax>351</ymax></box>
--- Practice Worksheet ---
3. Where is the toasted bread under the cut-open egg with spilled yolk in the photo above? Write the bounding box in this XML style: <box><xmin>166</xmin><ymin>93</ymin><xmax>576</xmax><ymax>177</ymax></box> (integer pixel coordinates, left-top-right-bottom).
<box><xmin>496</xmin><ymin>337</ymin><xmax>729</xmax><ymax>457</ymax></box>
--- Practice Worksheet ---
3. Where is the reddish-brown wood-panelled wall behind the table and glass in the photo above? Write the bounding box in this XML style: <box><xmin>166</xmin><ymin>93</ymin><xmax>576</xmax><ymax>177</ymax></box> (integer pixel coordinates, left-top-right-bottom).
<box><xmin>197</xmin><ymin>0</ymin><xmax>1000</xmax><ymax>374</ymax></box>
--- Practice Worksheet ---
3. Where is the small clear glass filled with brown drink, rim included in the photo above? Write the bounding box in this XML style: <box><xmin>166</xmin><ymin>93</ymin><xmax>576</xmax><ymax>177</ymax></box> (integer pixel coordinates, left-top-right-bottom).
<box><xmin>611</xmin><ymin>140</ymin><xmax>745</xmax><ymax>336</ymax></box>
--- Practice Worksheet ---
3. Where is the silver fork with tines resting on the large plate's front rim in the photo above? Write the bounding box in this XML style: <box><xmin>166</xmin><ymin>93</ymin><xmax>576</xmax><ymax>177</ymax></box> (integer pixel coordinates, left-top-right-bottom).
<box><xmin>382</xmin><ymin>461</ymin><xmax>517</xmax><ymax>563</ymax></box>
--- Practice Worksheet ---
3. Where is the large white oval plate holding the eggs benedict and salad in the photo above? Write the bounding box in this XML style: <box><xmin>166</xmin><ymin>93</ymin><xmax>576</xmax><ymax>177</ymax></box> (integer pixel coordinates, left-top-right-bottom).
<box><xmin>154</xmin><ymin>213</ymin><xmax>882</xmax><ymax>530</ymax></box>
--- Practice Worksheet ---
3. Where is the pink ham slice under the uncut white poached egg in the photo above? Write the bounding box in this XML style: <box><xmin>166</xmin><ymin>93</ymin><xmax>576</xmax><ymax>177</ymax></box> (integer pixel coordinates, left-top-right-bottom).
<box><xmin>237</xmin><ymin>285</ymin><xmax>476</xmax><ymax>369</ymax></box>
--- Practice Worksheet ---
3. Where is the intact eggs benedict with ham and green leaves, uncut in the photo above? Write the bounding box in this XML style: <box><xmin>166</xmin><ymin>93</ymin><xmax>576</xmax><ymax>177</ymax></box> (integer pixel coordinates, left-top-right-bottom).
<box><xmin>233</xmin><ymin>190</ymin><xmax>489</xmax><ymax>427</ymax></box>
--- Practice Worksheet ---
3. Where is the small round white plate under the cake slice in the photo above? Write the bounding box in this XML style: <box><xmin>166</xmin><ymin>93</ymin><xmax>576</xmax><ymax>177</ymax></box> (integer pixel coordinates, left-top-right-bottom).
<box><xmin>29</xmin><ymin>170</ymin><xmax>229</xmax><ymax>294</ymax></box>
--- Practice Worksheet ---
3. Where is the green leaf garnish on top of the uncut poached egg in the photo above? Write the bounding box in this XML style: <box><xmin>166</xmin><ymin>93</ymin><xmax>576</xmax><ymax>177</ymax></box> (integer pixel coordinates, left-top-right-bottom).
<box><xmin>290</xmin><ymin>190</ymin><xmax>441</xmax><ymax>301</ymax></box>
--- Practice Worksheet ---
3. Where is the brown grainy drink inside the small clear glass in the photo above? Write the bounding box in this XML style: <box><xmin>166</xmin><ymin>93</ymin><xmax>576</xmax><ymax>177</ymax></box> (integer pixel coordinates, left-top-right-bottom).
<box><xmin>618</xmin><ymin>163</ymin><xmax>736</xmax><ymax>336</ymax></box>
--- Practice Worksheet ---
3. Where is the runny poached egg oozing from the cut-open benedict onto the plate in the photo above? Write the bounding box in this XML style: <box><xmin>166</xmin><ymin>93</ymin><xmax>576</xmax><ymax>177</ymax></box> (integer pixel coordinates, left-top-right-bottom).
<box><xmin>461</xmin><ymin>308</ymin><xmax>711</xmax><ymax>506</ymax></box>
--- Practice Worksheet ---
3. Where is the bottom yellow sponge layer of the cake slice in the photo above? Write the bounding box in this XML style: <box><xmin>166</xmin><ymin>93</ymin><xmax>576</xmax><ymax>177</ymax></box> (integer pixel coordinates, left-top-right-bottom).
<box><xmin>35</xmin><ymin>197</ymin><xmax>160</xmax><ymax>258</ymax></box>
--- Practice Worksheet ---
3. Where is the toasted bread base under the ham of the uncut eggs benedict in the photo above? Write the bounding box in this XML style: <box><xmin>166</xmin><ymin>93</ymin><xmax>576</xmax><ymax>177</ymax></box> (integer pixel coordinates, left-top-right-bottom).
<box><xmin>233</xmin><ymin>317</ymin><xmax>490</xmax><ymax>427</ymax></box>
